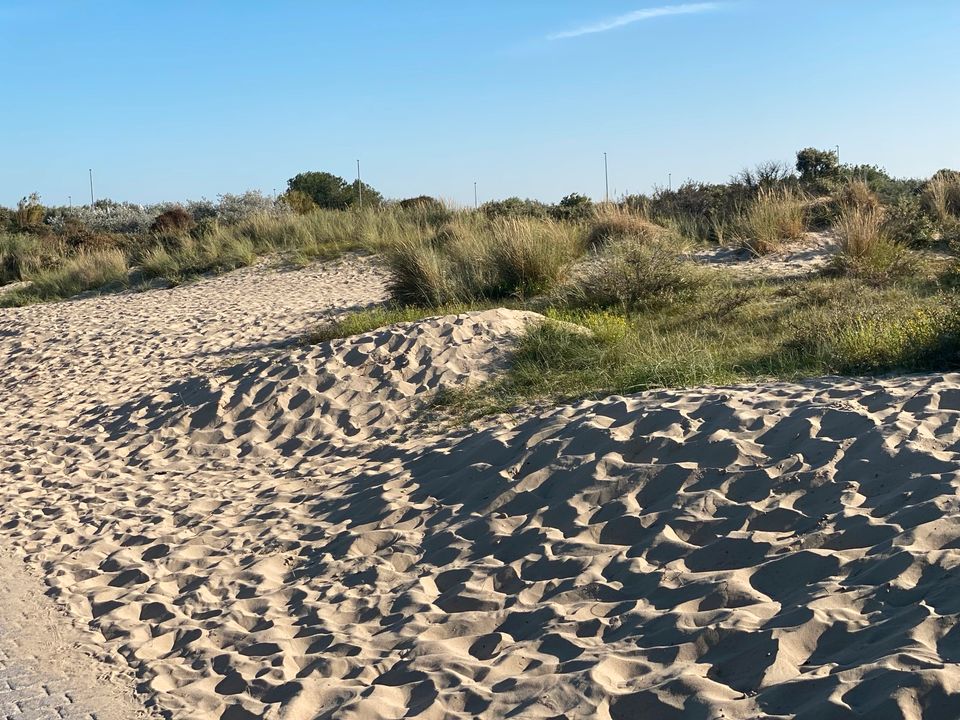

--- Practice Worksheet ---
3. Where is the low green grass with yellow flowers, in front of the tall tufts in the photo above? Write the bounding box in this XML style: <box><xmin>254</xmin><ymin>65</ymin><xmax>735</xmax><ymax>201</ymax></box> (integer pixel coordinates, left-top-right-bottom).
<box><xmin>312</xmin><ymin>255</ymin><xmax>960</xmax><ymax>420</ymax></box>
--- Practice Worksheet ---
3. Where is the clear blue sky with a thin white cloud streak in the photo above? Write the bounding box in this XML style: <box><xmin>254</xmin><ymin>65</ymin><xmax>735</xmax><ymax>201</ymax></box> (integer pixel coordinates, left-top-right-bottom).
<box><xmin>0</xmin><ymin>0</ymin><xmax>960</xmax><ymax>206</ymax></box>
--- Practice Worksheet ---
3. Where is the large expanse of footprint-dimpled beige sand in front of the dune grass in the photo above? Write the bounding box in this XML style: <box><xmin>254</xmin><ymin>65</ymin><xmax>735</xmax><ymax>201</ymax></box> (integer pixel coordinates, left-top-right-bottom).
<box><xmin>0</xmin><ymin>252</ymin><xmax>960</xmax><ymax>720</ymax></box>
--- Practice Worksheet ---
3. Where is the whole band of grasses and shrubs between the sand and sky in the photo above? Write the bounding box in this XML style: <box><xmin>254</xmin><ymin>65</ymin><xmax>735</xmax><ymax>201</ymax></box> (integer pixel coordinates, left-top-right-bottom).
<box><xmin>0</xmin><ymin>148</ymin><xmax>960</xmax><ymax>415</ymax></box>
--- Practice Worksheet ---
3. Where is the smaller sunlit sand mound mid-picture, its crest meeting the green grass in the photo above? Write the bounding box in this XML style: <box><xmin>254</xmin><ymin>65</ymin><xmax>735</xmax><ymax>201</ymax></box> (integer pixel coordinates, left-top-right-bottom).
<box><xmin>78</xmin><ymin>309</ymin><xmax>542</xmax><ymax>465</ymax></box>
